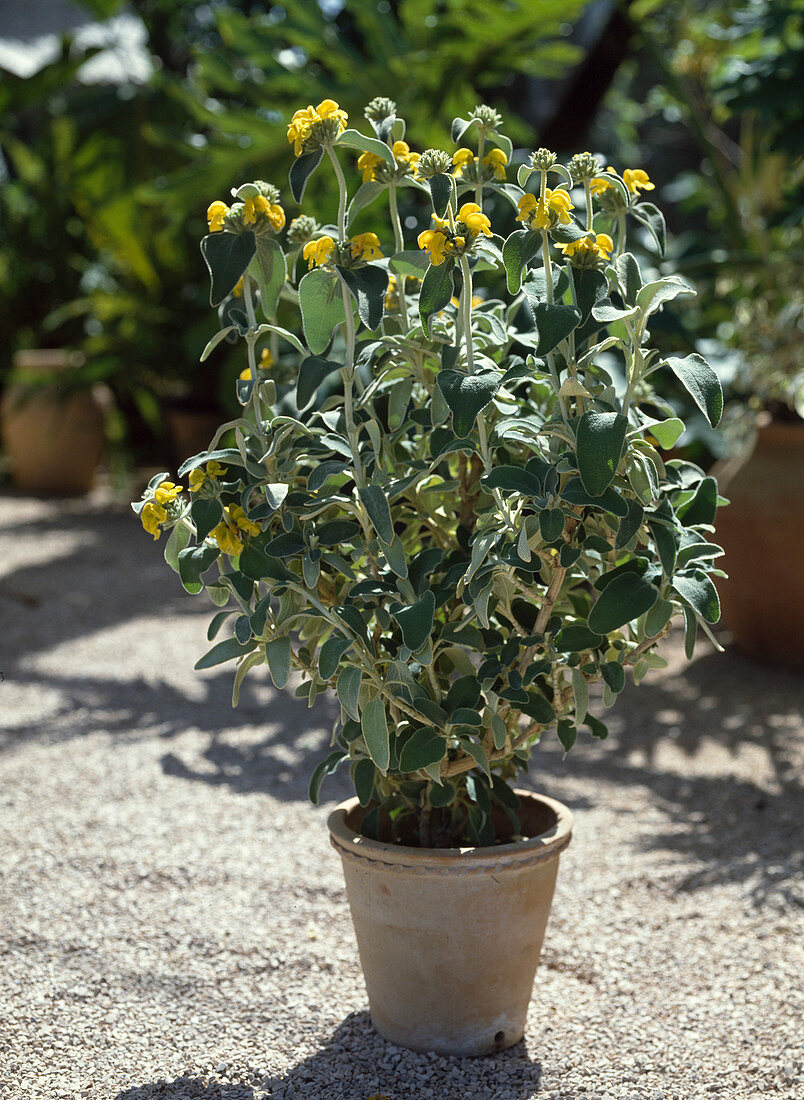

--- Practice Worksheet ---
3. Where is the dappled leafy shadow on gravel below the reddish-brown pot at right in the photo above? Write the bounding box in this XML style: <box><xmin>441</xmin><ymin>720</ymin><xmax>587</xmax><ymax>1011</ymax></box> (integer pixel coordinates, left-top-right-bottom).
<box><xmin>532</xmin><ymin>649</ymin><xmax>804</xmax><ymax>909</ymax></box>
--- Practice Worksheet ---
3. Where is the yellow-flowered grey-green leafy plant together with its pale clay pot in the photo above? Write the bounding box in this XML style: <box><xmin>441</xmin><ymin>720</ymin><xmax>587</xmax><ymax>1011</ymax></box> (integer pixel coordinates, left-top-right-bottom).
<box><xmin>134</xmin><ymin>98</ymin><xmax>722</xmax><ymax>1054</ymax></box>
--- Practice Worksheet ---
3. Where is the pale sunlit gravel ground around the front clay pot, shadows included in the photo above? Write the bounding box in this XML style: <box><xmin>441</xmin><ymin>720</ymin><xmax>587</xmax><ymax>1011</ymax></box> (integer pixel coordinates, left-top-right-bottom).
<box><xmin>0</xmin><ymin>495</ymin><xmax>804</xmax><ymax>1100</ymax></box>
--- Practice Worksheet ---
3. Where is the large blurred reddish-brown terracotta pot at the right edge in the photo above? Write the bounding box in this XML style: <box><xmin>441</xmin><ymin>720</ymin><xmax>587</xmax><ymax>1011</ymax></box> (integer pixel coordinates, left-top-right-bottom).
<box><xmin>715</xmin><ymin>421</ymin><xmax>804</xmax><ymax>669</ymax></box>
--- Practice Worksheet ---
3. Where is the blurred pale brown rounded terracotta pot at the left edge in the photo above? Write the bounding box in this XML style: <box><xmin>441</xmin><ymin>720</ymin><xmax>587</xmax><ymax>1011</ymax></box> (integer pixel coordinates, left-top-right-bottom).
<box><xmin>0</xmin><ymin>350</ymin><xmax>107</xmax><ymax>495</ymax></box>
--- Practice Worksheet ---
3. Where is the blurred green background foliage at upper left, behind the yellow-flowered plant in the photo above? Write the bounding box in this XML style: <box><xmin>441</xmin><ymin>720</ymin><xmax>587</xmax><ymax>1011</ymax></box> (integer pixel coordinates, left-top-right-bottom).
<box><xmin>0</xmin><ymin>0</ymin><xmax>588</xmax><ymax>459</ymax></box>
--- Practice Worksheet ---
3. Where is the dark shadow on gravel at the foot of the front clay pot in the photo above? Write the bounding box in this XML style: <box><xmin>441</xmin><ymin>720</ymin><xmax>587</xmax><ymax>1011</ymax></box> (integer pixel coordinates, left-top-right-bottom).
<box><xmin>263</xmin><ymin>1012</ymin><xmax>541</xmax><ymax>1100</ymax></box>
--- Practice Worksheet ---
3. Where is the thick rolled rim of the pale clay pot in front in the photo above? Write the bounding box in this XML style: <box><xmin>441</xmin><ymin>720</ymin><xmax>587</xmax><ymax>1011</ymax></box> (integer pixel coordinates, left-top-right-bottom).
<box><xmin>327</xmin><ymin>789</ymin><xmax>573</xmax><ymax>872</ymax></box>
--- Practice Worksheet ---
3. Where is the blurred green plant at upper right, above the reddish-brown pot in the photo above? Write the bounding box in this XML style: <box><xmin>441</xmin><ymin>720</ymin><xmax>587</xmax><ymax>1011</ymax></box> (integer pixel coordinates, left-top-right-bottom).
<box><xmin>603</xmin><ymin>0</ymin><xmax>804</xmax><ymax>442</ymax></box>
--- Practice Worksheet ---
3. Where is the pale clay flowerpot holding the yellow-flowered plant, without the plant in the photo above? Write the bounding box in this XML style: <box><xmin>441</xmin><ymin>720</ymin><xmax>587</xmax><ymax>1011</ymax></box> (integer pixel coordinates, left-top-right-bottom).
<box><xmin>328</xmin><ymin>791</ymin><xmax>572</xmax><ymax>1055</ymax></box>
